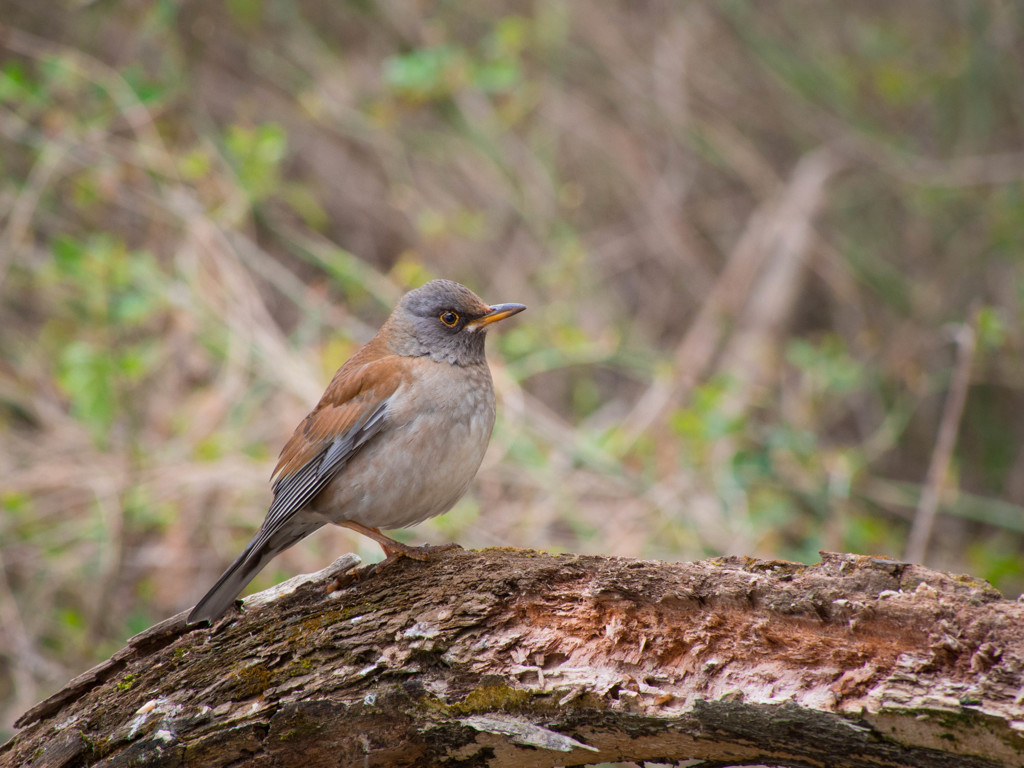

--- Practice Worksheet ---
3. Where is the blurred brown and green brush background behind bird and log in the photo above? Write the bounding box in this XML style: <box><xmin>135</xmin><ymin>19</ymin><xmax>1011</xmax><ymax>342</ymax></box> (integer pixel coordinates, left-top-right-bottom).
<box><xmin>0</xmin><ymin>0</ymin><xmax>1024</xmax><ymax>738</ymax></box>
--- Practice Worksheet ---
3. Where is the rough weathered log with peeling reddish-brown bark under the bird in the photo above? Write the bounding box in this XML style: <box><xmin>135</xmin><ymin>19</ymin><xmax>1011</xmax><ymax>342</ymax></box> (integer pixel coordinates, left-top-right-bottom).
<box><xmin>0</xmin><ymin>549</ymin><xmax>1024</xmax><ymax>768</ymax></box>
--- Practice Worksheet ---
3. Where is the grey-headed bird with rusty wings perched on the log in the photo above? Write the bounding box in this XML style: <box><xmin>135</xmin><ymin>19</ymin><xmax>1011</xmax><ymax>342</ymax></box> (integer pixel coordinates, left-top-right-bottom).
<box><xmin>187</xmin><ymin>280</ymin><xmax>526</xmax><ymax>624</ymax></box>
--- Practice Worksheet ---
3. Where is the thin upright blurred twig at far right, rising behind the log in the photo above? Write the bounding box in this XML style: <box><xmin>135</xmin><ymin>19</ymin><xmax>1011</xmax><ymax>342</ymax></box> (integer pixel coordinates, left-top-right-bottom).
<box><xmin>903</xmin><ymin>313</ymin><xmax>977</xmax><ymax>562</ymax></box>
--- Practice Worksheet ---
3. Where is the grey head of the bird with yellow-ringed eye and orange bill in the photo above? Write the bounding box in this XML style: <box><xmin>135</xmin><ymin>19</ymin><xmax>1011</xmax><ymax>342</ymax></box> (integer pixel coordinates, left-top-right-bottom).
<box><xmin>385</xmin><ymin>280</ymin><xmax>526</xmax><ymax>366</ymax></box>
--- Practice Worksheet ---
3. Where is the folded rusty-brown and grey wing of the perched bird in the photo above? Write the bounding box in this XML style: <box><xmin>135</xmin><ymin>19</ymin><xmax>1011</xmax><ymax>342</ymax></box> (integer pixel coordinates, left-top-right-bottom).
<box><xmin>258</xmin><ymin>355</ymin><xmax>403</xmax><ymax>539</ymax></box>
